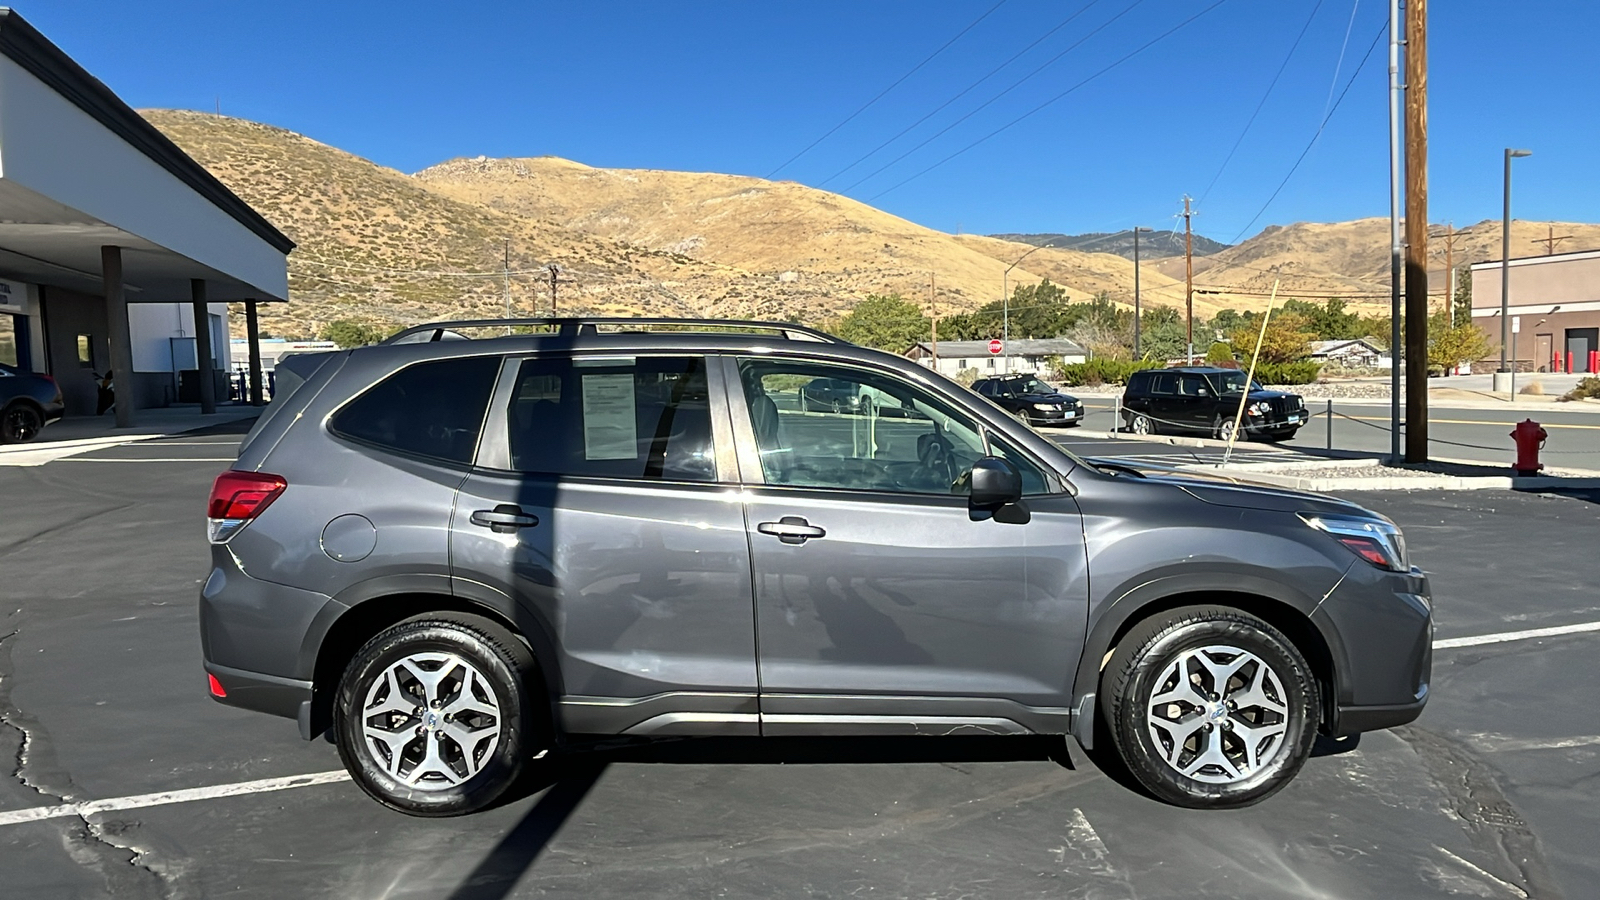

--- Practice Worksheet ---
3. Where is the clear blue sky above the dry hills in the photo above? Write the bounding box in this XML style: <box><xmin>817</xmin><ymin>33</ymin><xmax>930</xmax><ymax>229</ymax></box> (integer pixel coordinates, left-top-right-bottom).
<box><xmin>25</xmin><ymin>0</ymin><xmax>1600</xmax><ymax>240</ymax></box>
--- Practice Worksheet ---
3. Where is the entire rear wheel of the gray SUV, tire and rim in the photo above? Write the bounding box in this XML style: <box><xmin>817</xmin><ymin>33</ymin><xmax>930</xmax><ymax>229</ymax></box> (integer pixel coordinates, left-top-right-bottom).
<box><xmin>334</xmin><ymin>613</ymin><xmax>549</xmax><ymax>817</ymax></box>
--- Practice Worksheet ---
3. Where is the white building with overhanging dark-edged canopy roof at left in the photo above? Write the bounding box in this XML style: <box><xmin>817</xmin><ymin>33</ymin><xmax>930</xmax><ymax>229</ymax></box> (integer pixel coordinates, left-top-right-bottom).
<box><xmin>0</xmin><ymin>8</ymin><xmax>294</xmax><ymax>424</ymax></box>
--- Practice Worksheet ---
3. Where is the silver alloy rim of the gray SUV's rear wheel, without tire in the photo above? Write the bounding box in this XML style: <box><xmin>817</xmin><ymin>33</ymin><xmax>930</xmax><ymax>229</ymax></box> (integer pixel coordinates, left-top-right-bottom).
<box><xmin>358</xmin><ymin>652</ymin><xmax>502</xmax><ymax>791</ymax></box>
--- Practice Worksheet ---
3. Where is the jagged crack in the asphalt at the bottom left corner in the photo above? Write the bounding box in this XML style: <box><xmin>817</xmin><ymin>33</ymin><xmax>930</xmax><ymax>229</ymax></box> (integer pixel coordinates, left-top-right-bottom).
<box><xmin>0</xmin><ymin>612</ymin><xmax>178</xmax><ymax>900</ymax></box>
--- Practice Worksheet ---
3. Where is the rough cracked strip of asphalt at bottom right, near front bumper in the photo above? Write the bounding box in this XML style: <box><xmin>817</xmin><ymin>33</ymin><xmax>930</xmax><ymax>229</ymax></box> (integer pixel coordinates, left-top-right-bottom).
<box><xmin>1394</xmin><ymin>725</ymin><xmax>1563</xmax><ymax>900</ymax></box>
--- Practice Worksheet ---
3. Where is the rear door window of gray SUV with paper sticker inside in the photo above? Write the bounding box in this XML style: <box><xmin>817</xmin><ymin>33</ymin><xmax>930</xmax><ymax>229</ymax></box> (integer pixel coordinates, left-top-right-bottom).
<box><xmin>506</xmin><ymin>357</ymin><xmax>717</xmax><ymax>482</ymax></box>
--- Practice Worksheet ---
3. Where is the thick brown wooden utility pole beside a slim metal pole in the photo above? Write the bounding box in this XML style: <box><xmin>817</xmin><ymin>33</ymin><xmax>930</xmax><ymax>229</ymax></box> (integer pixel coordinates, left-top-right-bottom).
<box><xmin>1405</xmin><ymin>0</ymin><xmax>1427</xmax><ymax>463</ymax></box>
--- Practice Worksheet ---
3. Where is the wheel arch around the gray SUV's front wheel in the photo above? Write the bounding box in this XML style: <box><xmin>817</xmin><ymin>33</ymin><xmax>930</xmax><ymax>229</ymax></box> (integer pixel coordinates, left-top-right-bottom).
<box><xmin>1074</xmin><ymin>585</ymin><xmax>1339</xmax><ymax>735</ymax></box>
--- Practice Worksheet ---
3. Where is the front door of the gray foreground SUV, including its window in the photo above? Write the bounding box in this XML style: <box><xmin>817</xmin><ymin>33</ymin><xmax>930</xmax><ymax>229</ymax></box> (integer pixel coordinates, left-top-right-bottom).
<box><xmin>728</xmin><ymin>359</ymin><xmax>1086</xmax><ymax>735</ymax></box>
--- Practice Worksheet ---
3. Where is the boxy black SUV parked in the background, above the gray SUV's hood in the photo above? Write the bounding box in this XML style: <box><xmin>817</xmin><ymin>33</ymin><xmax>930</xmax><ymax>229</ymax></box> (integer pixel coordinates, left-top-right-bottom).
<box><xmin>1122</xmin><ymin>365</ymin><xmax>1306</xmax><ymax>440</ymax></box>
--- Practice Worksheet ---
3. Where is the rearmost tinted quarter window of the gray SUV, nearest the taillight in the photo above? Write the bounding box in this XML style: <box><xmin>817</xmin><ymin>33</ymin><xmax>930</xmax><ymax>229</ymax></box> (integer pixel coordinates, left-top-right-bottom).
<box><xmin>328</xmin><ymin>356</ymin><xmax>501</xmax><ymax>463</ymax></box>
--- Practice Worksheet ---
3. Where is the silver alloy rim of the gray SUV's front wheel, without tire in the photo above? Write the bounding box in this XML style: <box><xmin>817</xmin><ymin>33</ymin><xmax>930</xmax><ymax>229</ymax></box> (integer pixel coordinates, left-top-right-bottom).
<box><xmin>1146</xmin><ymin>644</ymin><xmax>1290</xmax><ymax>785</ymax></box>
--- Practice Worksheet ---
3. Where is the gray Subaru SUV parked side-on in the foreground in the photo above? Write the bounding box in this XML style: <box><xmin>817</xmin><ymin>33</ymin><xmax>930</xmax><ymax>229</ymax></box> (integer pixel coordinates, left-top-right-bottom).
<box><xmin>200</xmin><ymin>319</ymin><xmax>1432</xmax><ymax>815</ymax></box>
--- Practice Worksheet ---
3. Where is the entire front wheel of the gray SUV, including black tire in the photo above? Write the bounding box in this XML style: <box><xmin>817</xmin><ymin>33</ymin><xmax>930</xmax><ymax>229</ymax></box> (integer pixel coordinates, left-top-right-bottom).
<box><xmin>1101</xmin><ymin>607</ymin><xmax>1320</xmax><ymax>809</ymax></box>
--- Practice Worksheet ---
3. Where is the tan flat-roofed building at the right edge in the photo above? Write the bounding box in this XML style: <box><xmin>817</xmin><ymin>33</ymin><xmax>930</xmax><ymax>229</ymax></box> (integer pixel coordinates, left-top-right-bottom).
<box><xmin>1472</xmin><ymin>250</ymin><xmax>1600</xmax><ymax>373</ymax></box>
